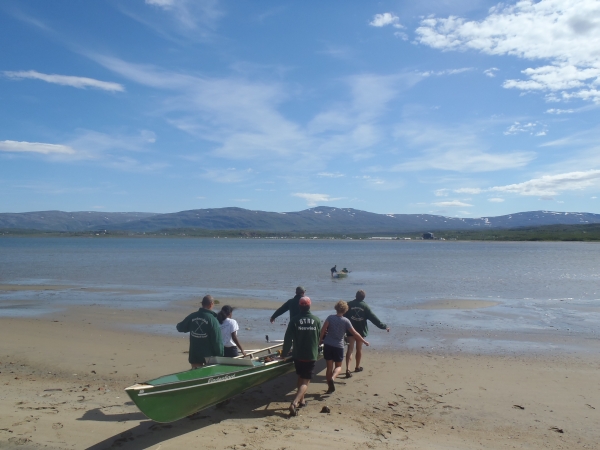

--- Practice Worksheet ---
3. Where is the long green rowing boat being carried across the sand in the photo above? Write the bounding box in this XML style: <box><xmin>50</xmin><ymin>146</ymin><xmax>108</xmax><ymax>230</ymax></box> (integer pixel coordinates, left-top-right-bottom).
<box><xmin>125</xmin><ymin>344</ymin><xmax>294</xmax><ymax>423</ymax></box>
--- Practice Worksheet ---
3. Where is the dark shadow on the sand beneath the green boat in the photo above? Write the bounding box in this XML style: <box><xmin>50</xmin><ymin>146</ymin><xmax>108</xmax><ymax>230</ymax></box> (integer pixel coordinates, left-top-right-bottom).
<box><xmin>84</xmin><ymin>360</ymin><xmax>327</xmax><ymax>450</ymax></box>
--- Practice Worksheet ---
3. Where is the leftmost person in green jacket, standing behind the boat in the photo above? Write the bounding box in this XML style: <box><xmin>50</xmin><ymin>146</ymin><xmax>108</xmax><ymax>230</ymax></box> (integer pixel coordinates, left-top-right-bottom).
<box><xmin>177</xmin><ymin>295</ymin><xmax>223</xmax><ymax>369</ymax></box>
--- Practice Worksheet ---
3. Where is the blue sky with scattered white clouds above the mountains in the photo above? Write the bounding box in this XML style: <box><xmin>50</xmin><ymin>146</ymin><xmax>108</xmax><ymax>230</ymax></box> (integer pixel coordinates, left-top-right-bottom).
<box><xmin>0</xmin><ymin>0</ymin><xmax>600</xmax><ymax>217</ymax></box>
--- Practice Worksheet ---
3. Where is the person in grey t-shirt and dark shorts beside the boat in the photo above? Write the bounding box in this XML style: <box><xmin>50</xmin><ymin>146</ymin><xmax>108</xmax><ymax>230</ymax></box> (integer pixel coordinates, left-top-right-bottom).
<box><xmin>320</xmin><ymin>300</ymin><xmax>369</xmax><ymax>394</ymax></box>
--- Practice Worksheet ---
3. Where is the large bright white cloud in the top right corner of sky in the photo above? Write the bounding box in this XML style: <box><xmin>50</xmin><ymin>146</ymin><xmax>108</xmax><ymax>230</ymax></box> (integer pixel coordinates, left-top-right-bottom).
<box><xmin>416</xmin><ymin>0</ymin><xmax>600</xmax><ymax>102</ymax></box>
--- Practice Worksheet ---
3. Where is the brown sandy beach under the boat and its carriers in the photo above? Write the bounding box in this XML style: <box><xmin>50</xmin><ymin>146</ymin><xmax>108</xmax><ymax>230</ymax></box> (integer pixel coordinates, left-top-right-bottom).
<box><xmin>0</xmin><ymin>301</ymin><xmax>600</xmax><ymax>450</ymax></box>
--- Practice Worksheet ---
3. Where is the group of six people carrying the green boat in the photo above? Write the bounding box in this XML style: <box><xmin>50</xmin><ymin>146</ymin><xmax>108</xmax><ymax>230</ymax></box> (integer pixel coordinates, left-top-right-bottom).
<box><xmin>177</xmin><ymin>286</ymin><xmax>390</xmax><ymax>416</ymax></box>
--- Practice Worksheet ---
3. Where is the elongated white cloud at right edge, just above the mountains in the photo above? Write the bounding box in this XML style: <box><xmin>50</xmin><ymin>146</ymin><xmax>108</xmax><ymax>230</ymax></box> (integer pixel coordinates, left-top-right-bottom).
<box><xmin>488</xmin><ymin>170</ymin><xmax>600</xmax><ymax>198</ymax></box>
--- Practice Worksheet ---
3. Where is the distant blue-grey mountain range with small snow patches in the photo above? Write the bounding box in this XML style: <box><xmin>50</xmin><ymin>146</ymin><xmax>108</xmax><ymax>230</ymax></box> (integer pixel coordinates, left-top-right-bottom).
<box><xmin>0</xmin><ymin>206</ymin><xmax>600</xmax><ymax>233</ymax></box>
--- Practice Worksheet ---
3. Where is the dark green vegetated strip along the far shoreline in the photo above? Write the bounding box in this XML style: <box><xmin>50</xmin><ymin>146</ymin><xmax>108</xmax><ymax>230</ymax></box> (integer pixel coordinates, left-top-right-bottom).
<box><xmin>0</xmin><ymin>224</ymin><xmax>600</xmax><ymax>242</ymax></box>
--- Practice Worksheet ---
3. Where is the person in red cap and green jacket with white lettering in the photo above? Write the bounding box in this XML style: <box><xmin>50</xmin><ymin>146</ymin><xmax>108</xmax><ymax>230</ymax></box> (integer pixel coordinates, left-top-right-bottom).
<box><xmin>281</xmin><ymin>297</ymin><xmax>321</xmax><ymax>416</ymax></box>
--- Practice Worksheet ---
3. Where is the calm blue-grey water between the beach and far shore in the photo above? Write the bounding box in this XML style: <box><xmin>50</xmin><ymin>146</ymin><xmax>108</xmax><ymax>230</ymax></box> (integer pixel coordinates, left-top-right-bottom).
<box><xmin>0</xmin><ymin>238</ymin><xmax>600</xmax><ymax>351</ymax></box>
